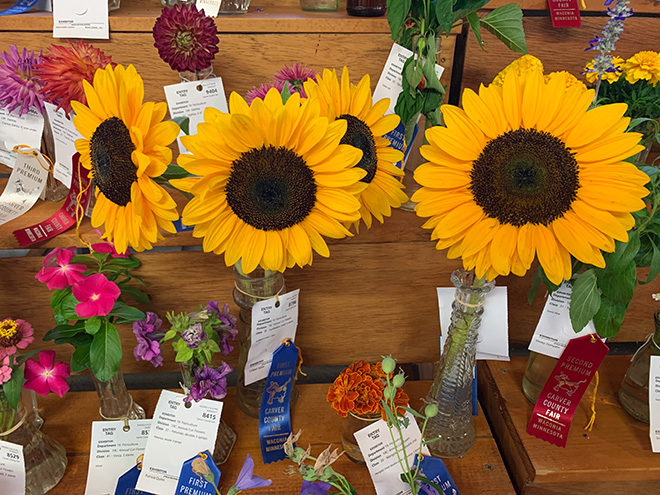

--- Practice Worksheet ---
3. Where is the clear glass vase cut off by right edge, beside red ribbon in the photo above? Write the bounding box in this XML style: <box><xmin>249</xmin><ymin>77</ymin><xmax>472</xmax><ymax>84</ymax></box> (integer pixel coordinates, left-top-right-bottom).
<box><xmin>619</xmin><ymin>310</ymin><xmax>660</xmax><ymax>423</ymax></box>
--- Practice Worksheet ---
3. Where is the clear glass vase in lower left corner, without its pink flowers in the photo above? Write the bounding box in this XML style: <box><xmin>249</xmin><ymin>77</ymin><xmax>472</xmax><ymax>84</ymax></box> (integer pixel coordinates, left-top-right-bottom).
<box><xmin>0</xmin><ymin>395</ymin><xmax>67</xmax><ymax>495</ymax></box>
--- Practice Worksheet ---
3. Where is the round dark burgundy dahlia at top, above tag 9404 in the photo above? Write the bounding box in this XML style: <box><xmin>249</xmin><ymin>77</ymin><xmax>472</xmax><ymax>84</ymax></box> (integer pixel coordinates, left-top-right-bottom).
<box><xmin>154</xmin><ymin>5</ymin><xmax>219</xmax><ymax>72</ymax></box>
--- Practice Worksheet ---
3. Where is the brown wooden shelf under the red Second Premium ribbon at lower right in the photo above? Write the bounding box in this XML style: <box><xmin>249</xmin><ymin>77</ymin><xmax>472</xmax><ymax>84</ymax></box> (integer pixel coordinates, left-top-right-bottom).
<box><xmin>479</xmin><ymin>356</ymin><xmax>660</xmax><ymax>495</ymax></box>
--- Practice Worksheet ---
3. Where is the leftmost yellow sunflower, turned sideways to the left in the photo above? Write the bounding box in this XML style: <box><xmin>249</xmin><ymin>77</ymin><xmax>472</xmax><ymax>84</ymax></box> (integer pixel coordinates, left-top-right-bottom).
<box><xmin>71</xmin><ymin>65</ymin><xmax>179</xmax><ymax>253</ymax></box>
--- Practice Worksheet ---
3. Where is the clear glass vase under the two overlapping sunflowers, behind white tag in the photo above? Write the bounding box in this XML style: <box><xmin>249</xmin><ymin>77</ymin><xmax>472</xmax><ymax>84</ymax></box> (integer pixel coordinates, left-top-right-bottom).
<box><xmin>234</xmin><ymin>261</ymin><xmax>295</xmax><ymax>418</ymax></box>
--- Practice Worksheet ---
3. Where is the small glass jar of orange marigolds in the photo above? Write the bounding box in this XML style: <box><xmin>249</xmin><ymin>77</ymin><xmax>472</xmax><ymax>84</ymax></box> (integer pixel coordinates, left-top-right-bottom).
<box><xmin>326</xmin><ymin>360</ymin><xmax>408</xmax><ymax>464</ymax></box>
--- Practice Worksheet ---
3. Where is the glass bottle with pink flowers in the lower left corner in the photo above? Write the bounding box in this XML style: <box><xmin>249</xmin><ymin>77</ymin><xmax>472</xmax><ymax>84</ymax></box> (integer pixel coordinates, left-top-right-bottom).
<box><xmin>0</xmin><ymin>318</ymin><xmax>71</xmax><ymax>495</ymax></box>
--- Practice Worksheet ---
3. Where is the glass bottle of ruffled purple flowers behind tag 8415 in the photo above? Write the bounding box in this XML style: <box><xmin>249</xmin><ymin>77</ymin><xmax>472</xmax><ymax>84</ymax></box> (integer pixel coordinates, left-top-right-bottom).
<box><xmin>133</xmin><ymin>301</ymin><xmax>238</xmax><ymax>464</ymax></box>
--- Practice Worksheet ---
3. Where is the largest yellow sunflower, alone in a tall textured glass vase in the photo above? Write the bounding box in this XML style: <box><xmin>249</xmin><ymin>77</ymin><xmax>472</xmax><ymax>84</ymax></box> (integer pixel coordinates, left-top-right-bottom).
<box><xmin>412</xmin><ymin>71</ymin><xmax>649</xmax><ymax>284</ymax></box>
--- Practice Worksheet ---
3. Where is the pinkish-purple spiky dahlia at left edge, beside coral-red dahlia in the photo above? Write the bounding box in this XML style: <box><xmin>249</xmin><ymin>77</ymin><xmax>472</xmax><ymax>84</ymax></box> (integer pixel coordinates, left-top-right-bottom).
<box><xmin>0</xmin><ymin>45</ymin><xmax>45</xmax><ymax>115</ymax></box>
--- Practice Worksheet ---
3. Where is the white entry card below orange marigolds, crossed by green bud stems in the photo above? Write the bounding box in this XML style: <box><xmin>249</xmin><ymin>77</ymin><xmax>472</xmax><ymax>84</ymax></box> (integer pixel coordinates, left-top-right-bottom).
<box><xmin>355</xmin><ymin>413</ymin><xmax>429</xmax><ymax>495</ymax></box>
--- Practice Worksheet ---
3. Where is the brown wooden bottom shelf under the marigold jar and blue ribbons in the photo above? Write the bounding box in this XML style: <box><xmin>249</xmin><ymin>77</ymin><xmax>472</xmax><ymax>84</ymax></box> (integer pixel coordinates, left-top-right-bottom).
<box><xmin>40</xmin><ymin>382</ymin><xmax>515</xmax><ymax>495</ymax></box>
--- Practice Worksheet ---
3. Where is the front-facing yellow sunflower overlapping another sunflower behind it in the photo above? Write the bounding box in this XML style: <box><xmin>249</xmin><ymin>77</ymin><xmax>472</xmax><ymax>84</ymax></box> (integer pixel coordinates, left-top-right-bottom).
<box><xmin>172</xmin><ymin>89</ymin><xmax>366</xmax><ymax>273</ymax></box>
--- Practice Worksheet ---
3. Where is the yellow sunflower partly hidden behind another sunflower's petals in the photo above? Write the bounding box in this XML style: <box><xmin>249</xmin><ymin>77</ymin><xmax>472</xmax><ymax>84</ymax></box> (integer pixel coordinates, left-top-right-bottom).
<box><xmin>304</xmin><ymin>67</ymin><xmax>408</xmax><ymax>228</ymax></box>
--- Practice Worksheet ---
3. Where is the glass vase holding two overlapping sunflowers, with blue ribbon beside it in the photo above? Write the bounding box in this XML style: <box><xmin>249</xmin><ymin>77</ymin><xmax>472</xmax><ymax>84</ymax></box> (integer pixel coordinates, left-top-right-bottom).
<box><xmin>170</xmin><ymin>70</ymin><xmax>408</xmax><ymax>417</ymax></box>
